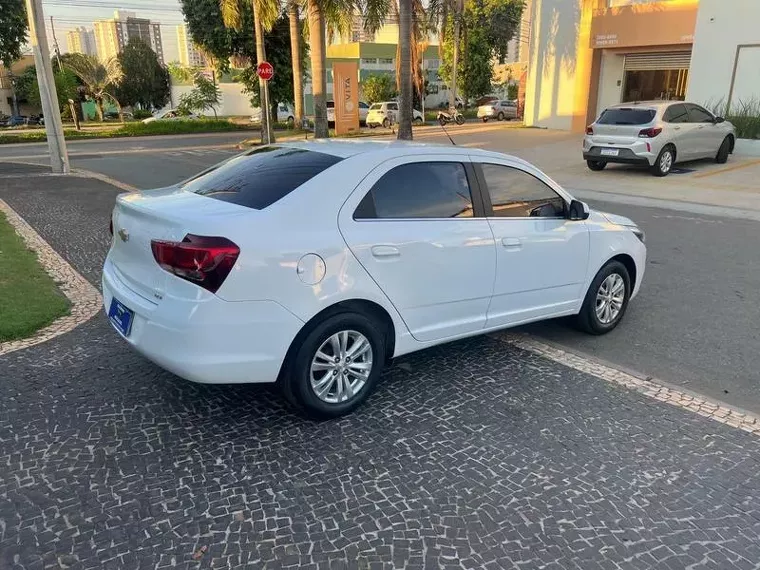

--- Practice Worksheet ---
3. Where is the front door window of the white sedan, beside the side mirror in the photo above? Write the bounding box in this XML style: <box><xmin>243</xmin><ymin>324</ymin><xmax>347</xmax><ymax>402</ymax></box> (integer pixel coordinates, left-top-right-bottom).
<box><xmin>482</xmin><ymin>164</ymin><xmax>565</xmax><ymax>218</ymax></box>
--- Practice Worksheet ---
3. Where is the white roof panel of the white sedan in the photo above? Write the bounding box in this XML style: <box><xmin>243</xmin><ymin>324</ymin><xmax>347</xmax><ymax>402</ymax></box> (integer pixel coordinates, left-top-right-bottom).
<box><xmin>276</xmin><ymin>139</ymin><xmax>529</xmax><ymax>164</ymax></box>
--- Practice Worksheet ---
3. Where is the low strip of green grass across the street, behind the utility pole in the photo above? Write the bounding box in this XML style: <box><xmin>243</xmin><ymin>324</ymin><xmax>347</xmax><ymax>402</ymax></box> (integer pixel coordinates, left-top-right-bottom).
<box><xmin>0</xmin><ymin>119</ymin><xmax>252</xmax><ymax>144</ymax></box>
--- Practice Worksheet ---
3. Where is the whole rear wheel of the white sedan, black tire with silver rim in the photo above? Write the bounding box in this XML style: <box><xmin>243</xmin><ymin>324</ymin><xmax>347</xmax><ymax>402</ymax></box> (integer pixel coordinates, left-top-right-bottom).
<box><xmin>282</xmin><ymin>312</ymin><xmax>385</xmax><ymax>419</ymax></box>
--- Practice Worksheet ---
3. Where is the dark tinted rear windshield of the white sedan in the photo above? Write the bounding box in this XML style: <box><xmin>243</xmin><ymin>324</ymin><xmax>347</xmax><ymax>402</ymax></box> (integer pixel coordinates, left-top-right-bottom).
<box><xmin>182</xmin><ymin>146</ymin><xmax>342</xmax><ymax>210</ymax></box>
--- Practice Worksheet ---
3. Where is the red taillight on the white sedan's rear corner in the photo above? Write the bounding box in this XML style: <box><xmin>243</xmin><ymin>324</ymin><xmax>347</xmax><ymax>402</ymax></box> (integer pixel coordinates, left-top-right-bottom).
<box><xmin>150</xmin><ymin>234</ymin><xmax>240</xmax><ymax>293</ymax></box>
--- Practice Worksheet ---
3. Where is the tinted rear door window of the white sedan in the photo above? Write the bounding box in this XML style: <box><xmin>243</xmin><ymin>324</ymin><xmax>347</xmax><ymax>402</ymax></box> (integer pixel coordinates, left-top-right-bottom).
<box><xmin>354</xmin><ymin>162</ymin><xmax>472</xmax><ymax>220</ymax></box>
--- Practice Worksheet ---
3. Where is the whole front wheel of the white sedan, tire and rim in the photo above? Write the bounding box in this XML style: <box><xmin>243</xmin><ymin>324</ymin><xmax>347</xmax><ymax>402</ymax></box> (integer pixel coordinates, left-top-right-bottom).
<box><xmin>577</xmin><ymin>260</ymin><xmax>631</xmax><ymax>335</ymax></box>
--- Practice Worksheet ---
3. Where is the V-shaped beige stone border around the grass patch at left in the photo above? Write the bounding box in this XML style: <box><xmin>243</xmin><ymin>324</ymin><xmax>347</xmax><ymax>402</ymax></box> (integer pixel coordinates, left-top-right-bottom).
<box><xmin>0</xmin><ymin>200</ymin><xmax>103</xmax><ymax>355</ymax></box>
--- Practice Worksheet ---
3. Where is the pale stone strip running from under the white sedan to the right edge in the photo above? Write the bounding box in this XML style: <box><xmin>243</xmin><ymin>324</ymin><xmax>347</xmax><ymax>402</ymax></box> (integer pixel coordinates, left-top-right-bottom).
<box><xmin>494</xmin><ymin>333</ymin><xmax>760</xmax><ymax>435</ymax></box>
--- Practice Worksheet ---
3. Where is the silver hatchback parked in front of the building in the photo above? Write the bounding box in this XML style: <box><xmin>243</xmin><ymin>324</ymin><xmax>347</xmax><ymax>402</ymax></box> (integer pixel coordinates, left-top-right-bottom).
<box><xmin>583</xmin><ymin>101</ymin><xmax>736</xmax><ymax>176</ymax></box>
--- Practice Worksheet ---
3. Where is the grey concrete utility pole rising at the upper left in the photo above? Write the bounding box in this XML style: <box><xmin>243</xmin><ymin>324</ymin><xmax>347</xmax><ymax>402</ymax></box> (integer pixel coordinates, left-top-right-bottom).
<box><xmin>26</xmin><ymin>0</ymin><xmax>69</xmax><ymax>174</ymax></box>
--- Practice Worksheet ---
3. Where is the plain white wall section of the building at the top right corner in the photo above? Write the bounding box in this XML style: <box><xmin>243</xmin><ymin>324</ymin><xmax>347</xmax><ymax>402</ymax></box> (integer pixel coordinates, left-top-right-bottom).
<box><xmin>686</xmin><ymin>0</ymin><xmax>760</xmax><ymax>109</ymax></box>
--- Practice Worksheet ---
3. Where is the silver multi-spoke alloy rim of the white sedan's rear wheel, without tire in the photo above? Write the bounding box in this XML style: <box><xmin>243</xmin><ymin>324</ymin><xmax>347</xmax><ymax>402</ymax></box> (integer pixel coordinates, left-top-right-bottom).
<box><xmin>309</xmin><ymin>330</ymin><xmax>373</xmax><ymax>404</ymax></box>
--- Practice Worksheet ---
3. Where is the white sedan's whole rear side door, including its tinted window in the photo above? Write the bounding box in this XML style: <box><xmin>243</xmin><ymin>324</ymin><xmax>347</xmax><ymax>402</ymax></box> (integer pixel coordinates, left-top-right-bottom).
<box><xmin>339</xmin><ymin>154</ymin><xmax>496</xmax><ymax>341</ymax></box>
